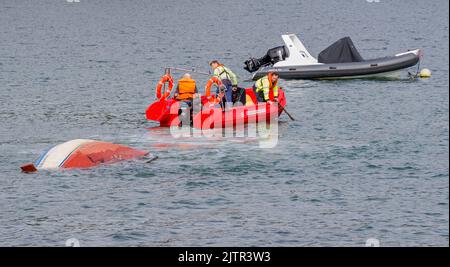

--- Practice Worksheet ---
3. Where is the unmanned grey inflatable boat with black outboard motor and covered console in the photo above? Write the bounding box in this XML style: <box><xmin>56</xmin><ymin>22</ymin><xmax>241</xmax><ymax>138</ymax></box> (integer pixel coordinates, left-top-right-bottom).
<box><xmin>244</xmin><ymin>34</ymin><xmax>422</xmax><ymax>80</ymax></box>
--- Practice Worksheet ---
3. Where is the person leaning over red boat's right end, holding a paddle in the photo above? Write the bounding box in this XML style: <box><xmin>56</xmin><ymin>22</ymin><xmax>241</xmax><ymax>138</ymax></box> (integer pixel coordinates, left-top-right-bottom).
<box><xmin>253</xmin><ymin>72</ymin><xmax>280</xmax><ymax>102</ymax></box>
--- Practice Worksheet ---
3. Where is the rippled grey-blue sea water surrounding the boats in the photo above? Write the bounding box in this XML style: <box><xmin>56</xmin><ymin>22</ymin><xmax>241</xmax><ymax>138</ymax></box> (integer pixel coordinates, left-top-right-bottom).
<box><xmin>0</xmin><ymin>0</ymin><xmax>449</xmax><ymax>246</ymax></box>
